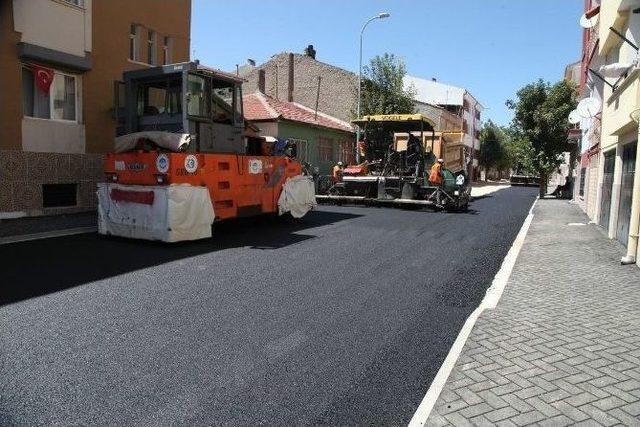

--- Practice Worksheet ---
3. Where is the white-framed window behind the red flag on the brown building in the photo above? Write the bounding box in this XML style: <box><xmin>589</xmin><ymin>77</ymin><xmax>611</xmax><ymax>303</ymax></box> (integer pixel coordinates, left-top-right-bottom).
<box><xmin>22</xmin><ymin>66</ymin><xmax>78</xmax><ymax>122</ymax></box>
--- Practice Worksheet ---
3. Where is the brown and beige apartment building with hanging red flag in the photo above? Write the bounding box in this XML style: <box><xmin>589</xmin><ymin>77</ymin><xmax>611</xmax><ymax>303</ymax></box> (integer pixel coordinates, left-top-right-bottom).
<box><xmin>0</xmin><ymin>0</ymin><xmax>191</xmax><ymax>218</ymax></box>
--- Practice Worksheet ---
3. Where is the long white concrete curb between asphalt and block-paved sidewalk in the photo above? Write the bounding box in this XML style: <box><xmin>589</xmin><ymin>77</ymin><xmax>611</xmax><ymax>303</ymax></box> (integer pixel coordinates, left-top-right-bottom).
<box><xmin>409</xmin><ymin>197</ymin><xmax>539</xmax><ymax>427</ymax></box>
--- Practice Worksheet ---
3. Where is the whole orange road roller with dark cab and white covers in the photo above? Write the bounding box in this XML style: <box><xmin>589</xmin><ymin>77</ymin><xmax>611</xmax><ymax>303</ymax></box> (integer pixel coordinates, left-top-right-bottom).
<box><xmin>97</xmin><ymin>61</ymin><xmax>315</xmax><ymax>242</ymax></box>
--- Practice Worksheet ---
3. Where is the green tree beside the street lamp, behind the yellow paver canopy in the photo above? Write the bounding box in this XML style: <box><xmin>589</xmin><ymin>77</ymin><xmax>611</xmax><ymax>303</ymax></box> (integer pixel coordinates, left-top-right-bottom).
<box><xmin>354</xmin><ymin>53</ymin><xmax>415</xmax><ymax>116</ymax></box>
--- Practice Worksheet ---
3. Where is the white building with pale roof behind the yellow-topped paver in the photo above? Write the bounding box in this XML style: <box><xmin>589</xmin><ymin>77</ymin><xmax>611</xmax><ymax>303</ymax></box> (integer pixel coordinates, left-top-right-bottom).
<box><xmin>404</xmin><ymin>76</ymin><xmax>484</xmax><ymax>180</ymax></box>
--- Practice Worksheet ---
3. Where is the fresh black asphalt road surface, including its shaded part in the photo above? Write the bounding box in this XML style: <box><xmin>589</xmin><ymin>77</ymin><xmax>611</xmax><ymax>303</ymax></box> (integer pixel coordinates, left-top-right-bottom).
<box><xmin>0</xmin><ymin>188</ymin><xmax>537</xmax><ymax>425</ymax></box>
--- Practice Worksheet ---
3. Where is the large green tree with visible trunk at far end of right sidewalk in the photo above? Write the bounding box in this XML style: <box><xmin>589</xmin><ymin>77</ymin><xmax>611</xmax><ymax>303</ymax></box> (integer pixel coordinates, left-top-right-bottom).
<box><xmin>507</xmin><ymin>80</ymin><xmax>576</xmax><ymax>196</ymax></box>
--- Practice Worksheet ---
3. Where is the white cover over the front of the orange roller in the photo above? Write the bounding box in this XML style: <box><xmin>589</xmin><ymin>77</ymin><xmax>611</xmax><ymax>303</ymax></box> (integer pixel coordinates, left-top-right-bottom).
<box><xmin>98</xmin><ymin>183</ymin><xmax>215</xmax><ymax>242</ymax></box>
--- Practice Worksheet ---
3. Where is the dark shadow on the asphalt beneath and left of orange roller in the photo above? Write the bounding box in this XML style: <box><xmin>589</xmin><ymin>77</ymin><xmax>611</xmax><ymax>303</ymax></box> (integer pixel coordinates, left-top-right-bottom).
<box><xmin>0</xmin><ymin>211</ymin><xmax>362</xmax><ymax>306</ymax></box>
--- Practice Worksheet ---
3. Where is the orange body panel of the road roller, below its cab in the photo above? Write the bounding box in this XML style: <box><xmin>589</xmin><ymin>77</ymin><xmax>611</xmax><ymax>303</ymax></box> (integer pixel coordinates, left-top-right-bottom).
<box><xmin>105</xmin><ymin>152</ymin><xmax>301</xmax><ymax>220</ymax></box>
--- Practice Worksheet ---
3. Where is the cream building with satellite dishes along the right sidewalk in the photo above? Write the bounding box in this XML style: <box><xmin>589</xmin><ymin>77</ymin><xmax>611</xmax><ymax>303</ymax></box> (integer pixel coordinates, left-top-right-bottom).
<box><xmin>583</xmin><ymin>0</ymin><xmax>640</xmax><ymax>263</ymax></box>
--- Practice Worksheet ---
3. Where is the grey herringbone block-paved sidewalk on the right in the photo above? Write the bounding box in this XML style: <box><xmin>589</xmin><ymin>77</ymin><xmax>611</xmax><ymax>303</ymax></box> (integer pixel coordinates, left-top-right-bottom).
<box><xmin>427</xmin><ymin>199</ymin><xmax>640</xmax><ymax>426</ymax></box>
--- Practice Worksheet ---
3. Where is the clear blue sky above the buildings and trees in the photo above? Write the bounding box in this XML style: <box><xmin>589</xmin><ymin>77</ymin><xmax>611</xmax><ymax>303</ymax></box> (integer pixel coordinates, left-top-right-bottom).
<box><xmin>191</xmin><ymin>0</ymin><xmax>583</xmax><ymax>124</ymax></box>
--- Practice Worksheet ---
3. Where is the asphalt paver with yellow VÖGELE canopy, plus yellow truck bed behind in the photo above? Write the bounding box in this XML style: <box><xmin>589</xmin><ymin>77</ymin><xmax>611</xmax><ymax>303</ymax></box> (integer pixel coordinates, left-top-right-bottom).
<box><xmin>316</xmin><ymin>114</ymin><xmax>471</xmax><ymax>210</ymax></box>
